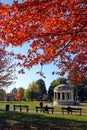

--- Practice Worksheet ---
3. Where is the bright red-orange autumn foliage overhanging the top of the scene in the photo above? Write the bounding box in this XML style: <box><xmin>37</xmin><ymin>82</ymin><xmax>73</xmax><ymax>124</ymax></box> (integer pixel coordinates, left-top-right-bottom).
<box><xmin>0</xmin><ymin>0</ymin><xmax>87</xmax><ymax>83</ymax></box>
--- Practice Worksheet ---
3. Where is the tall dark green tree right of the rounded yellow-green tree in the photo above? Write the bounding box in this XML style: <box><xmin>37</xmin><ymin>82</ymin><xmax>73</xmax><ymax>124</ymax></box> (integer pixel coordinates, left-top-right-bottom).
<box><xmin>36</xmin><ymin>79</ymin><xmax>47</xmax><ymax>99</ymax></box>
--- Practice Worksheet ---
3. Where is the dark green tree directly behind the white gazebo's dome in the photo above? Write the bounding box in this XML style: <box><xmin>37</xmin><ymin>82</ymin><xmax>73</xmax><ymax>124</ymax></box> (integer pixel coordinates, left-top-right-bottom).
<box><xmin>48</xmin><ymin>77</ymin><xmax>68</xmax><ymax>101</ymax></box>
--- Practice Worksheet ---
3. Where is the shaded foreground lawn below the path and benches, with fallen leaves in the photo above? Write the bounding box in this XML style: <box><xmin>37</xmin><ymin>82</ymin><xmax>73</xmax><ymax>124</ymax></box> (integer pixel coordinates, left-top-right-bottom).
<box><xmin>0</xmin><ymin>111</ymin><xmax>87</xmax><ymax>130</ymax></box>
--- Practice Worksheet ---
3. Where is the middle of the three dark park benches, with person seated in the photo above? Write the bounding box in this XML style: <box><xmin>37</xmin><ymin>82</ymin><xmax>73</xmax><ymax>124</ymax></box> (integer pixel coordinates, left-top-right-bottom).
<box><xmin>36</xmin><ymin>106</ymin><xmax>54</xmax><ymax>114</ymax></box>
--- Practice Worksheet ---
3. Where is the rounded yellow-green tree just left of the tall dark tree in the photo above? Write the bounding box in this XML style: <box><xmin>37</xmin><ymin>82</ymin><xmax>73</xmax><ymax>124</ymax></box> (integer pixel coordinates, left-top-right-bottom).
<box><xmin>25</xmin><ymin>82</ymin><xmax>39</xmax><ymax>101</ymax></box>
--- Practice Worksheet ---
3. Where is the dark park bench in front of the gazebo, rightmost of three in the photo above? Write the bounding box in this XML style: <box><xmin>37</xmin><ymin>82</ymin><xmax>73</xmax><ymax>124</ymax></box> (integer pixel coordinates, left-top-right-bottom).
<box><xmin>61</xmin><ymin>107</ymin><xmax>82</xmax><ymax>115</ymax></box>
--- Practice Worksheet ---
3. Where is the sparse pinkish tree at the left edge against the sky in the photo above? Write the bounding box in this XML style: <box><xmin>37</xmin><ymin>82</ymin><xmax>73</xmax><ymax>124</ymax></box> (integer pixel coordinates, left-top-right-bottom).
<box><xmin>0</xmin><ymin>47</ymin><xmax>15</xmax><ymax>88</ymax></box>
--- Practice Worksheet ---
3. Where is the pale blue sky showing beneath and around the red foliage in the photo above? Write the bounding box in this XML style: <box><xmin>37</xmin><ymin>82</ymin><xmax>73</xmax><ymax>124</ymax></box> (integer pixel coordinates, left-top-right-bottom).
<box><xmin>0</xmin><ymin>0</ymin><xmax>65</xmax><ymax>92</ymax></box>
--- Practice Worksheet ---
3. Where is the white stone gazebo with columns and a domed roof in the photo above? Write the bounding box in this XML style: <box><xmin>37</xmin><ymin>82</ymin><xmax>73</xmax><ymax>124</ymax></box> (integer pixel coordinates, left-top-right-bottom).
<box><xmin>54</xmin><ymin>84</ymin><xmax>75</xmax><ymax>105</ymax></box>
